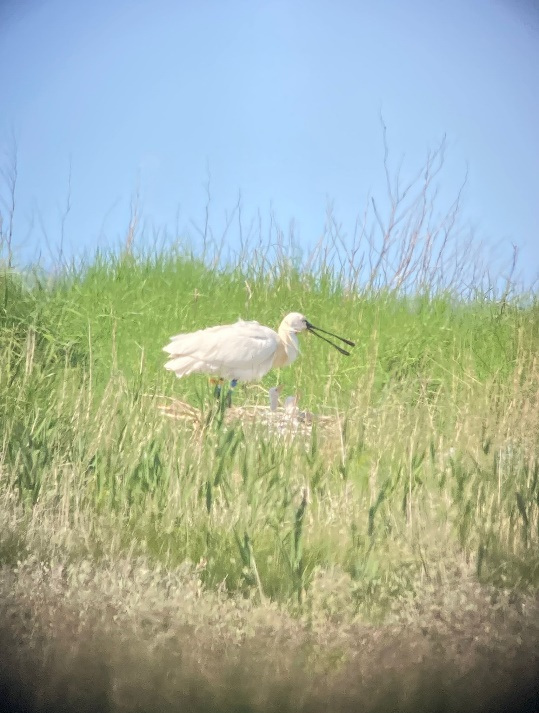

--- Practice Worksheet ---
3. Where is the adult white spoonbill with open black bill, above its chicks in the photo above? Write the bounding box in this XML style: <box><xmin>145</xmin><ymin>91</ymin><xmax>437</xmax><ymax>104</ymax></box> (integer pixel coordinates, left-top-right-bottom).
<box><xmin>163</xmin><ymin>312</ymin><xmax>355</xmax><ymax>394</ymax></box>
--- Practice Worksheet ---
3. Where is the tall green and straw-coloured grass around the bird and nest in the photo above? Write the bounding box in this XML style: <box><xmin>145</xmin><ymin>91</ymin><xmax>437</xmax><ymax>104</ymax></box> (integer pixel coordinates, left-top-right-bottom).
<box><xmin>0</xmin><ymin>236</ymin><xmax>539</xmax><ymax>618</ymax></box>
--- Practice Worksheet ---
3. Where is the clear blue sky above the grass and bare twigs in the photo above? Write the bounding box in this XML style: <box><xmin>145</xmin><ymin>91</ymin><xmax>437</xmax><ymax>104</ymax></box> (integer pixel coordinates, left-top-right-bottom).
<box><xmin>0</xmin><ymin>0</ymin><xmax>539</xmax><ymax>281</ymax></box>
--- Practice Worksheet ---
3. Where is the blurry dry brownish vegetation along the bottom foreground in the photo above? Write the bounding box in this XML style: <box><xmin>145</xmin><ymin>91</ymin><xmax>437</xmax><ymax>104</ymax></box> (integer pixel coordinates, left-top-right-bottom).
<box><xmin>0</xmin><ymin>559</ymin><xmax>539</xmax><ymax>713</ymax></box>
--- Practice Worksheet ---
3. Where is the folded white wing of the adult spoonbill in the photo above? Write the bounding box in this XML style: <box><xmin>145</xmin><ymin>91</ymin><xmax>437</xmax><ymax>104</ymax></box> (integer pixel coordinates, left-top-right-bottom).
<box><xmin>164</xmin><ymin>321</ymin><xmax>279</xmax><ymax>380</ymax></box>
